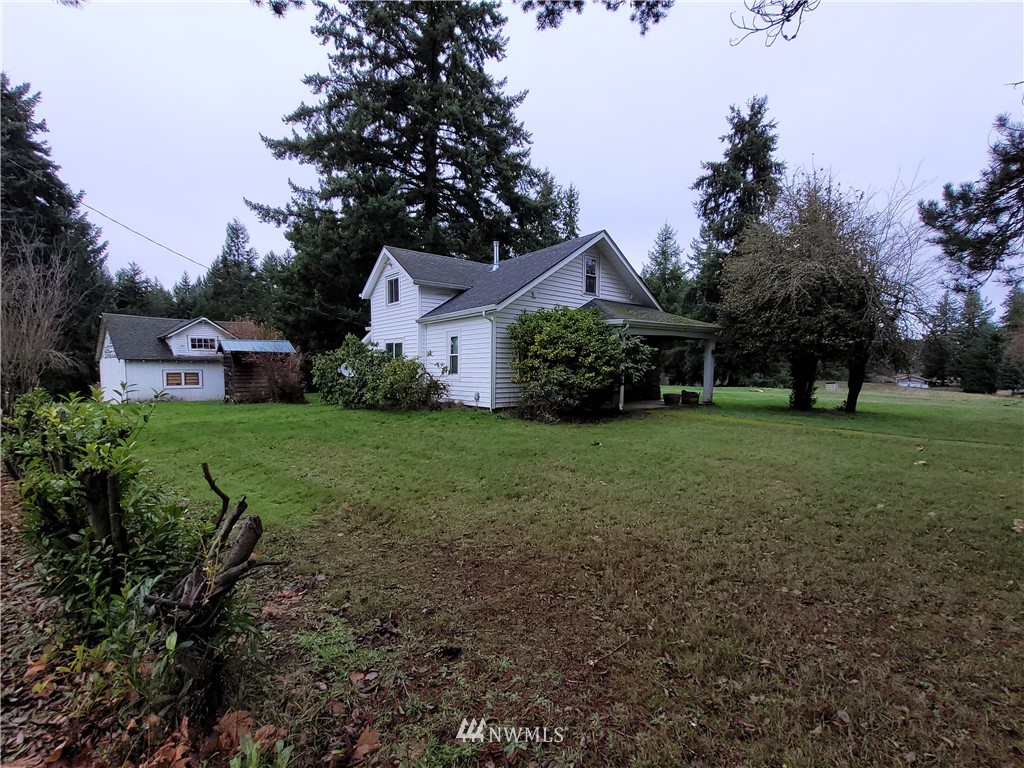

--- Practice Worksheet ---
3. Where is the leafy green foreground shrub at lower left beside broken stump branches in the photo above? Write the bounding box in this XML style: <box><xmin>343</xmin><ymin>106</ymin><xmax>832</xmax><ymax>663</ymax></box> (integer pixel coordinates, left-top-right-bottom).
<box><xmin>3</xmin><ymin>389</ymin><xmax>254</xmax><ymax>724</ymax></box>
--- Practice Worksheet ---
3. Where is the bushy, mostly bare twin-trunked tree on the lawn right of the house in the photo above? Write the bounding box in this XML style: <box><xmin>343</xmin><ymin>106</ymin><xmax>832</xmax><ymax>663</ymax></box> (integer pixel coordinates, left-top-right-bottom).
<box><xmin>723</xmin><ymin>173</ymin><xmax>927</xmax><ymax>413</ymax></box>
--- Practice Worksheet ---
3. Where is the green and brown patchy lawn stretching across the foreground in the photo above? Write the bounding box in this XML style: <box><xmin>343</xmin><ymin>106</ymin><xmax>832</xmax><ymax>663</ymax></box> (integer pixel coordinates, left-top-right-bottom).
<box><xmin>140</xmin><ymin>388</ymin><xmax>1024</xmax><ymax>766</ymax></box>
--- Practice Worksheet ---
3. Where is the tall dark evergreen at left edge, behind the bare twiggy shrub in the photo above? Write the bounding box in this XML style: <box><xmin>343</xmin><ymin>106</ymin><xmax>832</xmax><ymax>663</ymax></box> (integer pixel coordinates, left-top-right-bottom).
<box><xmin>0</xmin><ymin>73</ymin><xmax>111</xmax><ymax>391</ymax></box>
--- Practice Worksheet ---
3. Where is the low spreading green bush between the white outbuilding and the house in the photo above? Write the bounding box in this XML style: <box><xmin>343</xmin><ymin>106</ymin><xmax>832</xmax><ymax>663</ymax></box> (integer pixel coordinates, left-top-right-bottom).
<box><xmin>312</xmin><ymin>334</ymin><xmax>447</xmax><ymax>411</ymax></box>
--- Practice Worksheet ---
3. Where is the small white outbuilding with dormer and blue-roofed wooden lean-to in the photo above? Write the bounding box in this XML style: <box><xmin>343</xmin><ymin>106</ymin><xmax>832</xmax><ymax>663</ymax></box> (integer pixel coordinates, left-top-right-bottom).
<box><xmin>96</xmin><ymin>313</ymin><xmax>295</xmax><ymax>400</ymax></box>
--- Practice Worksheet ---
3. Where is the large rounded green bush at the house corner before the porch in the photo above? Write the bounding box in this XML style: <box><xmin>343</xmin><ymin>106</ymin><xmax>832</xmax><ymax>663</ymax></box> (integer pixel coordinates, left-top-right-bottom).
<box><xmin>508</xmin><ymin>307</ymin><xmax>652</xmax><ymax>421</ymax></box>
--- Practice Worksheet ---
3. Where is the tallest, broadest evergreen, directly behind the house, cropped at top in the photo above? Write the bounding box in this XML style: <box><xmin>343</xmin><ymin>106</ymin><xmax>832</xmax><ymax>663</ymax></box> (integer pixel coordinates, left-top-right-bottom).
<box><xmin>250</xmin><ymin>0</ymin><xmax>557</xmax><ymax>352</ymax></box>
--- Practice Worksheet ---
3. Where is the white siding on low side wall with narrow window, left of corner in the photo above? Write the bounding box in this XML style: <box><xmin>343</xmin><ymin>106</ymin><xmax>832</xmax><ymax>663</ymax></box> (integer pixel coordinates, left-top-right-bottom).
<box><xmin>423</xmin><ymin>315</ymin><xmax>490</xmax><ymax>408</ymax></box>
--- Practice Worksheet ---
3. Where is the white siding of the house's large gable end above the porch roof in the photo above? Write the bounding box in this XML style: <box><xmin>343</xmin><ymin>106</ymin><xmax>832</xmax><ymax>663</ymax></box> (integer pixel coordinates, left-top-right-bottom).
<box><xmin>495</xmin><ymin>246</ymin><xmax>634</xmax><ymax>408</ymax></box>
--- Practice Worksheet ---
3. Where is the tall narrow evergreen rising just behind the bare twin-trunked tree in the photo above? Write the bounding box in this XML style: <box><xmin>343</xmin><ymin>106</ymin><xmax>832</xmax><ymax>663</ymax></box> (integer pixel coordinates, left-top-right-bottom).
<box><xmin>692</xmin><ymin>96</ymin><xmax>785</xmax><ymax>322</ymax></box>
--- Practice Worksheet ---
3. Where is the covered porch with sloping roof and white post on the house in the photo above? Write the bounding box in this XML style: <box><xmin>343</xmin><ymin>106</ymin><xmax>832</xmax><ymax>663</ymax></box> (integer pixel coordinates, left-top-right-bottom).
<box><xmin>585</xmin><ymin>299</ymin><xmax>722</xmax><ymax>411</ymax></box>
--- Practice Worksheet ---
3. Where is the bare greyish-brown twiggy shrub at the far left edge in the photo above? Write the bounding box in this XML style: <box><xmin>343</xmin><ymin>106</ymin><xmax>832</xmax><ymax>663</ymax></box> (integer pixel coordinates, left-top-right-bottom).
<box><xmin>0</xmin><ymin>232</ymin><xmax>76</xmax><ymax>408</ymax></box>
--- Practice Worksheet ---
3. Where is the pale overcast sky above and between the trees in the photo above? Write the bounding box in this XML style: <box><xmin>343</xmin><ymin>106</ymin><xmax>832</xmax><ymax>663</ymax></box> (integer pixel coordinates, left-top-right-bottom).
<box><xmin>0</xmin><ymin>0</ymin><xmax>1024</xmax><ymax>303</ymax></box>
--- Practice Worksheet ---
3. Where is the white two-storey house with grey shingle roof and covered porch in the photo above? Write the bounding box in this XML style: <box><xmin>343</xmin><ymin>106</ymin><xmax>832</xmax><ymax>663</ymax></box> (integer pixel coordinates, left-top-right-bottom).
<box><xmin>361</xmin><ymin>230</ymin><xmax>721</xmax><ymax>410</ymax></box>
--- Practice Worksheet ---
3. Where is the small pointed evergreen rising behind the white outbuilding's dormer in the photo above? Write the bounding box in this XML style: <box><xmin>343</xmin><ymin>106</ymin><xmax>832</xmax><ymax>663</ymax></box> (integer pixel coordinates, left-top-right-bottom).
<box><xmin>196</xmin><ymin>219</ymin><xmax>262</xmax><ymax>319</ymax></box>
